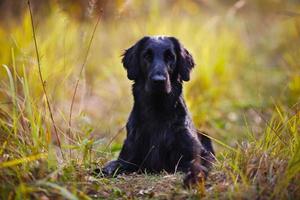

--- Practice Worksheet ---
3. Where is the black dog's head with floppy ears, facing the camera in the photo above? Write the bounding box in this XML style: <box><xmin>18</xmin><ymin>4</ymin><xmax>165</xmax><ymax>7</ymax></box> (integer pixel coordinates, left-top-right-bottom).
<box><xmin>122</xmin><ymin>36</ymin><xmax>194</xmax><ymax>94</ymax></box>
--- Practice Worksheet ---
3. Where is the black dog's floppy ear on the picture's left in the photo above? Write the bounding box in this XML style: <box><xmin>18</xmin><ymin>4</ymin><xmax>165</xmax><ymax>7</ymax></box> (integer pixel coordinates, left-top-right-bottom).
<box><xmin>122</xmin><ymin>36</ymin><xmax>149</xmax><ymax>80</ymax></box>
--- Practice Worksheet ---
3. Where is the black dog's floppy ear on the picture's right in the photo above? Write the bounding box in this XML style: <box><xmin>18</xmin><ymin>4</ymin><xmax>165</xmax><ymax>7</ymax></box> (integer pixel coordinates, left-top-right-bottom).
<box><xmin>170</xmin><ymin>37</ymin><xmax>195</xmax><ymax>81</ymax></box>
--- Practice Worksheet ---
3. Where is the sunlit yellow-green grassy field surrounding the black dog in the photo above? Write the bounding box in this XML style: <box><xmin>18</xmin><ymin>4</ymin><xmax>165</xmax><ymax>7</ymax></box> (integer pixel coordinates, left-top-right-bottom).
<box><xmin>0</xmin><ymin>0</ymin><xmax>300</xmax><ymax>199</ymax></box>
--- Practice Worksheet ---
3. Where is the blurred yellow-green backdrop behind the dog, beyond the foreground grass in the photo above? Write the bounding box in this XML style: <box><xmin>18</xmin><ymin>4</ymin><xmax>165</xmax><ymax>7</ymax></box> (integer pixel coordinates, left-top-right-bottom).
<box><xmin>0</xmin><ymin>0</ymin><xmax>300</xmax><ymax>162</ymax></box>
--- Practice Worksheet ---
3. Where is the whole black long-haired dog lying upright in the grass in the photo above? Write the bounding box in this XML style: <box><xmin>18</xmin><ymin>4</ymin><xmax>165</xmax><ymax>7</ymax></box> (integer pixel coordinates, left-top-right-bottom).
<box><xmin>102</xmin><ymin>37</ymin><xmax>214</xmax><ymax>186</ymax></box>
